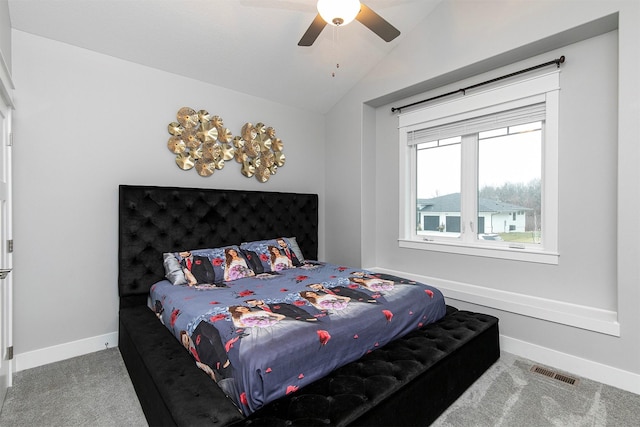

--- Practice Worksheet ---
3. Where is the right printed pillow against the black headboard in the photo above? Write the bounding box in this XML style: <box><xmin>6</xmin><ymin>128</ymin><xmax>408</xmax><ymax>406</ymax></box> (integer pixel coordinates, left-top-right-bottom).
<box><xmin>240</xmin><ymin>237</ymin><xmax>304</xmax><ymax>272</ymax></box>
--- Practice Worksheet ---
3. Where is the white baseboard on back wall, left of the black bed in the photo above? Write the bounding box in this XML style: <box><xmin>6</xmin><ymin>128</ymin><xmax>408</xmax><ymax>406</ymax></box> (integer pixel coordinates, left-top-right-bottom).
<box><xmin>14</xmin><ymin>332</ymin><xmax>118</xmax><ymax>372</ymax></box>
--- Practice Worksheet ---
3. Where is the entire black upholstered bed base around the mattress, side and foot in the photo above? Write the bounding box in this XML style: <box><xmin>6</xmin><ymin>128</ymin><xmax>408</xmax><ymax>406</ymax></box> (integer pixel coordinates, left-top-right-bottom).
<box><xmin>119</xmin><ymin>307</ymin><xmax>500</xmax><ymax>427</ymax></box>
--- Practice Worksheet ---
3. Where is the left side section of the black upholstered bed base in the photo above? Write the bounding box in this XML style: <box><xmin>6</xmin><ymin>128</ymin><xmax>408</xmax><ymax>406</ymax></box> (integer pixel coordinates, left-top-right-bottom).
<box><xmin>118</xmin><ymin>305</ymin><xmax>244</xmax><ymax>427</ymax></box>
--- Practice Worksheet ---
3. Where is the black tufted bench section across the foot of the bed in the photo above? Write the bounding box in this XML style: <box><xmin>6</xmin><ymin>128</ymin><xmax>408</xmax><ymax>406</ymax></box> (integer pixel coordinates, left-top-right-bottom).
<box><xmin>237</xmin><ymin>307</ymin><xmax>500</xmax><ymax>427</ymax></box>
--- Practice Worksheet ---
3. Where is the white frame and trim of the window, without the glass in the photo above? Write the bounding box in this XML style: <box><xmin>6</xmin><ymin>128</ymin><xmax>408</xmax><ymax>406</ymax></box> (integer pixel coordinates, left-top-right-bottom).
<box><xmin>398</xmin><ymin>70</ymin><xmax>560</xmax><ymax>264</ymax></box>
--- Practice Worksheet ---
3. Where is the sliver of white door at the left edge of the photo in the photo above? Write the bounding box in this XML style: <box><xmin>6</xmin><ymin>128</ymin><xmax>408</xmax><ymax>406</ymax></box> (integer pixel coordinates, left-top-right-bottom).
<box><xmin>0</xmin><ymin>87</ymin><xmax>13</xmax><ymax>407</ymax></box>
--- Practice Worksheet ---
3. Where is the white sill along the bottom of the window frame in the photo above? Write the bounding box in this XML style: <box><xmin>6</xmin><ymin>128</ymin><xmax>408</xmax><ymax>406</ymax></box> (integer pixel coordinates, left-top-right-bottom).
<box><xmin>398</xmin><ymin>239</ymin><xmax>560</xmax><ymax>265</ymax></box>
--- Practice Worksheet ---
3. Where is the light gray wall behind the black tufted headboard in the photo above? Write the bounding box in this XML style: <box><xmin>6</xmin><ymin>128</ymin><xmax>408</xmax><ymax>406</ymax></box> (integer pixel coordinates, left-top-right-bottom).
<box><xmin>13</xmin><ymin>30</ymin><xmax>325</xmax><ymax>361</ymax></box>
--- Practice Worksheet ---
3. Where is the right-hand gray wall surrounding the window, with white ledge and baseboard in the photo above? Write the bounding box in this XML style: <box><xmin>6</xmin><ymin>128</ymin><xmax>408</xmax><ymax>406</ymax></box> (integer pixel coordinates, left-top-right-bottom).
<box><xmin>326</xmin><ymin>0</ymin><xmax>640</xmax><ymax>392</ymax></box>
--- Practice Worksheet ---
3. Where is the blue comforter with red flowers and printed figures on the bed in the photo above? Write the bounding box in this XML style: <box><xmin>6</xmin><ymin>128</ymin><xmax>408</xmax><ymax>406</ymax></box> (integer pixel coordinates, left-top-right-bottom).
<box><xmin>150</xmin><ymin>262</ymin><xmax>445</xmax><ymax>415</ymax></box>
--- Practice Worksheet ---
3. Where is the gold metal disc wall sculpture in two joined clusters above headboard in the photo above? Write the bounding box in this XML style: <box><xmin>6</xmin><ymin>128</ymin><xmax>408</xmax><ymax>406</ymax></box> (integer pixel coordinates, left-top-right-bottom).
<box><xmin>167</xmin><ymin>107</ymin><xmax>285</xmax><ymax>182</ymax></box>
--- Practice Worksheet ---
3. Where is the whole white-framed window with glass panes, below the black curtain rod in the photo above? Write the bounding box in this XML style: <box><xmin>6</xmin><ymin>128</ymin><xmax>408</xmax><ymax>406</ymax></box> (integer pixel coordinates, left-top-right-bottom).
<box><xmin>399</xmin><ymin>71</ymin><xmax>559</xmax><ymax>264</ymax></box>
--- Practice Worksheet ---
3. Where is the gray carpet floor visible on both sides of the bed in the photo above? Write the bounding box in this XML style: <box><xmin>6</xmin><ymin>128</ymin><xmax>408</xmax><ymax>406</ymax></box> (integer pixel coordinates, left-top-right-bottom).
<box><xmin>0</xmin><ymin>348</ymin><xmax>640</xmax><ymax>427</ymax></box>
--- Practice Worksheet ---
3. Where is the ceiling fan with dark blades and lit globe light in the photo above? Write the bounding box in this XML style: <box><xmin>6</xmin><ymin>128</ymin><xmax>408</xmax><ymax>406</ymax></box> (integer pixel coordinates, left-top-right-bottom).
<box><xmin>298</xmin><ymin>0</ymin><xmax>400</xmax><ymax>46</ymax></box>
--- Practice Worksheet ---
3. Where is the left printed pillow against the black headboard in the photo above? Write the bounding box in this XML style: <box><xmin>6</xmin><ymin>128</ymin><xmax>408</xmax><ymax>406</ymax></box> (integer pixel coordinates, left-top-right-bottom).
<box><xmin>164</xmin><ymin>245</ymin><xmax>255</xmax><ymax>285</ymax></box>
